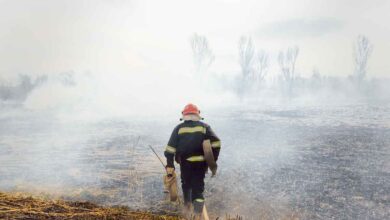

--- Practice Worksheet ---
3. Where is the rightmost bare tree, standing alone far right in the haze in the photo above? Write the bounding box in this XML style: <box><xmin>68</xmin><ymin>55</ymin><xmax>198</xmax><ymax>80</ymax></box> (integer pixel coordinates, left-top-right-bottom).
<box><xmin>353</xmin><ymin>35</ymin><xmax>373</xmax><ymax>84</ymax></box>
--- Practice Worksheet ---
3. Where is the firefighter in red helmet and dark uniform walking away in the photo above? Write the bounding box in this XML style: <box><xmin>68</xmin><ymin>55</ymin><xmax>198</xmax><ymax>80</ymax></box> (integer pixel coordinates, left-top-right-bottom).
<box><xmin>164</xmin><ymin>104</ymin><xmax>221</xmax><ymax>215</ymax></box>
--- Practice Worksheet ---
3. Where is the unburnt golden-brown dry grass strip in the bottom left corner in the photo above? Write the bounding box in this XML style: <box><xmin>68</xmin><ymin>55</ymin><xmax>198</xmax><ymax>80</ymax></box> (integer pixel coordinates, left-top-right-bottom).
<box><xmin>0</xmin><ymin>192</ymin><xmax>181</xmax><ymax>220</ymax></box>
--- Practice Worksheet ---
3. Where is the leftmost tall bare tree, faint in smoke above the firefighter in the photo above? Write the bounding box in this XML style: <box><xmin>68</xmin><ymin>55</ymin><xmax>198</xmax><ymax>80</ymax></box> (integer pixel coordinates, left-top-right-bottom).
<box><xmin>190</xmin><ymin>33</ymin><xmax>215</xmax><ymax>73</ymax></box>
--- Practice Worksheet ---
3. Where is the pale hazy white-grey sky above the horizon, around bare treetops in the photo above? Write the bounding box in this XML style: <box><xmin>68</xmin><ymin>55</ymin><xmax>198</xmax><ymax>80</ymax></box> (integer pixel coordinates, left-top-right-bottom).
<box><xmin>0</xmin><ymin>0</ymin><xmax>390</xmax><ymax>79</ymax></box>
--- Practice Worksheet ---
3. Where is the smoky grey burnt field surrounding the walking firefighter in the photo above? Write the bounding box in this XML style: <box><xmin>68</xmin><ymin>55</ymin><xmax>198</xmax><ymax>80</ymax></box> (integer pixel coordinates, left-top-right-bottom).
<box><xmin>0</xmin><ymin>105</ymin><xmax>390</xmax><ymax>219</ymax></box>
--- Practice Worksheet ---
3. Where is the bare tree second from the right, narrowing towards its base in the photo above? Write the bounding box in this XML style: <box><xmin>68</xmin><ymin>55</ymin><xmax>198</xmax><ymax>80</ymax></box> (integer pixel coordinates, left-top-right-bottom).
<box><xmin>278</xmin><ymin>46</ymin><xmax>299</xmax><ymax>95</ymax></box>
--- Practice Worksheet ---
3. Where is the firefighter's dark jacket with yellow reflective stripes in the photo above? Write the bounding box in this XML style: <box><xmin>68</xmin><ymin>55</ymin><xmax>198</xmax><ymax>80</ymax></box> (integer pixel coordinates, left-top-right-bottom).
<box><xmin>164</xmin><ymin>121</ymin><xmax>221</xmax><ymax>167</ymax></box>
